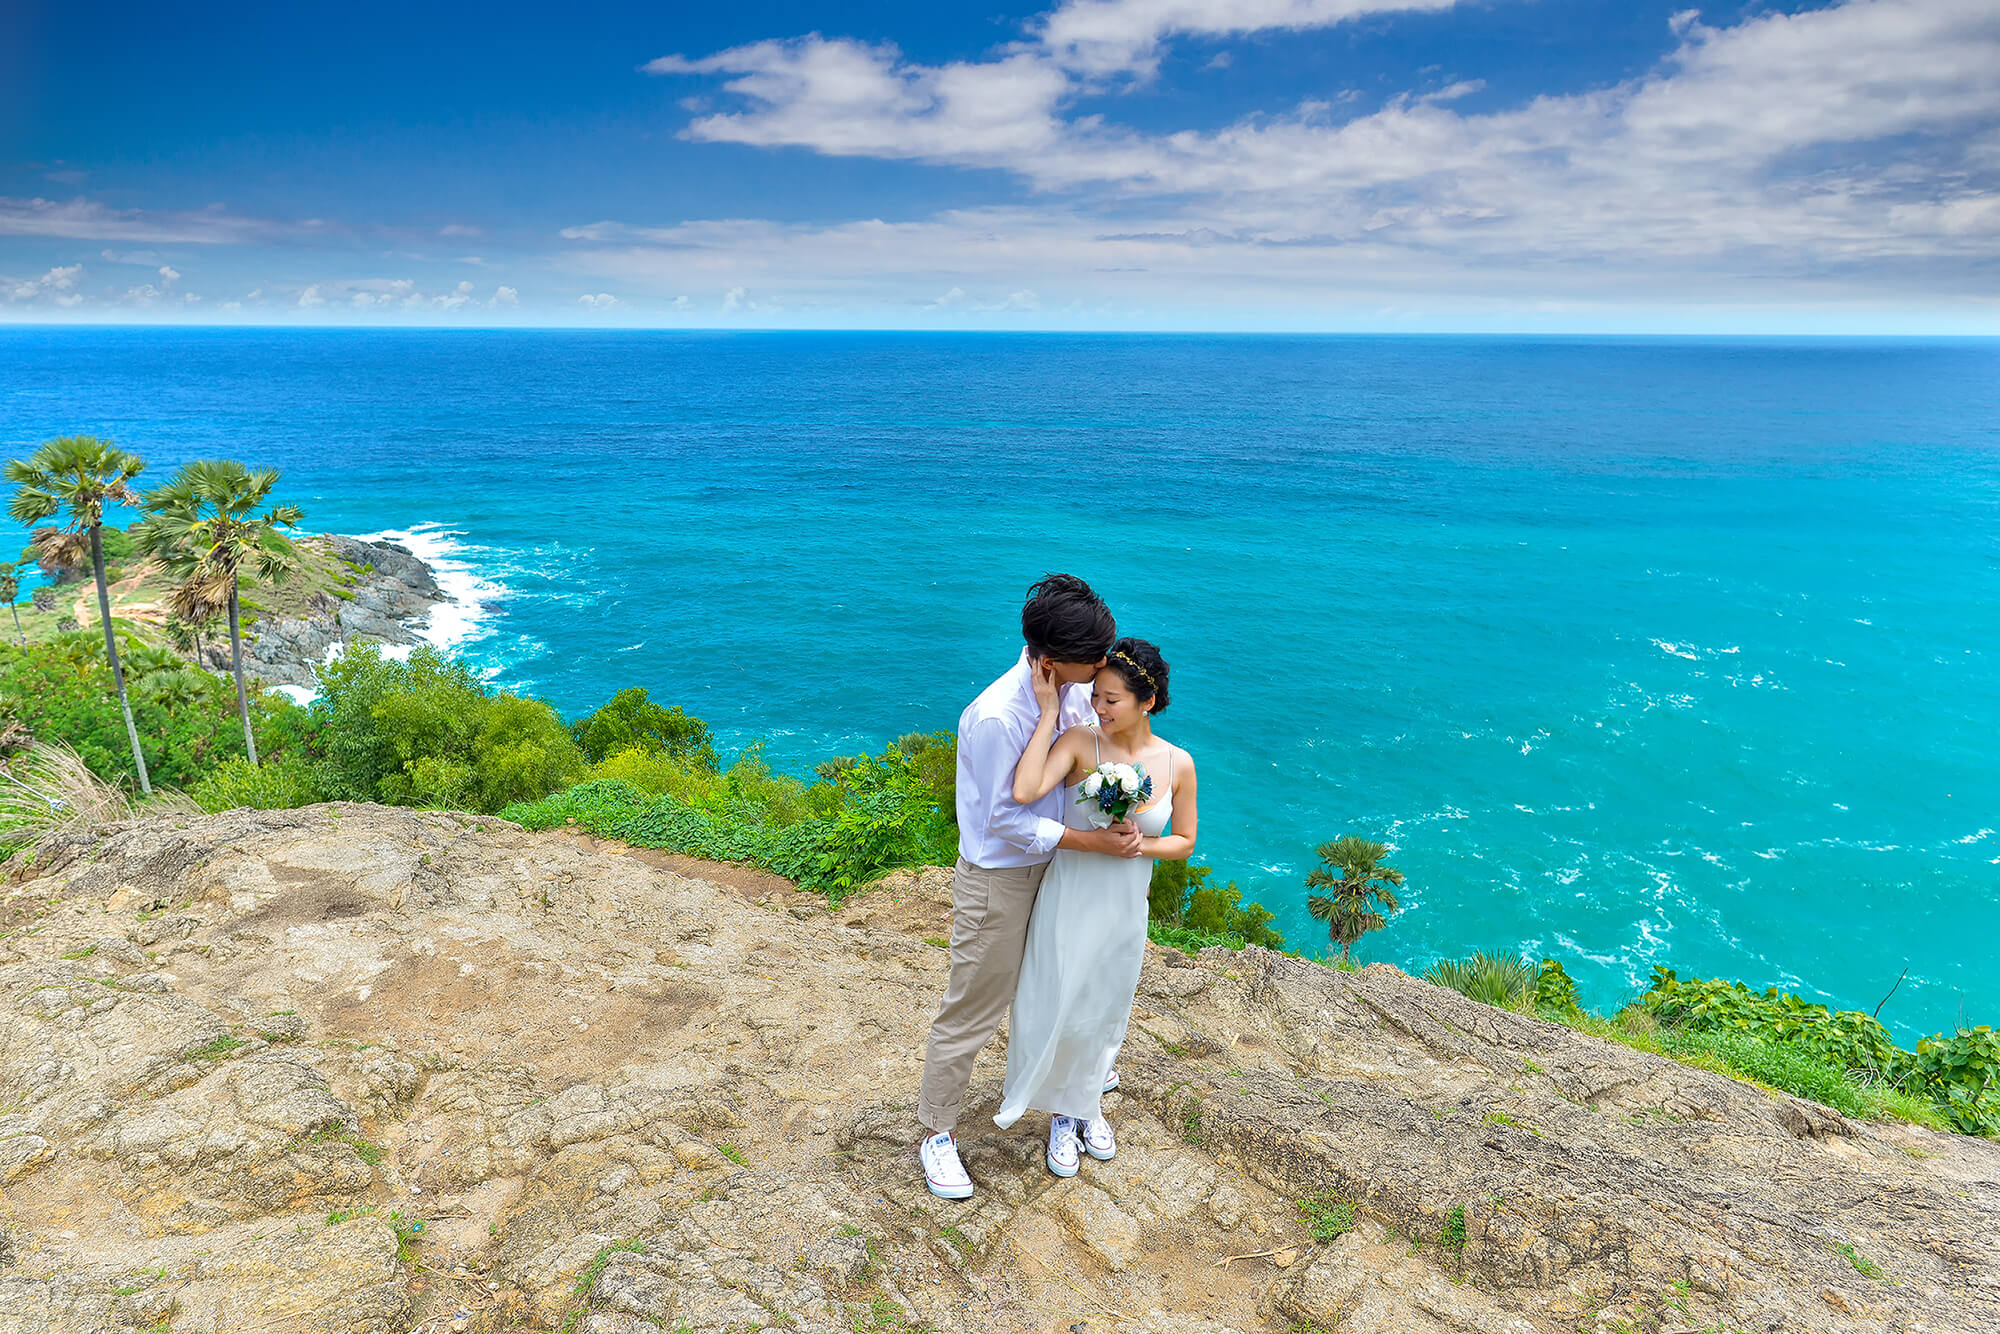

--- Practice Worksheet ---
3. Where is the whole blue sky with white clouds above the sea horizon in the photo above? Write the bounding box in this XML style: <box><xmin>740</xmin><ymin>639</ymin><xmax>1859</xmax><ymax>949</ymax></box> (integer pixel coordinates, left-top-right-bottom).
<box><xmin>0</xmin><ymin>0</ymin><xmax>2000</xmax><ymax>334</ymax></box>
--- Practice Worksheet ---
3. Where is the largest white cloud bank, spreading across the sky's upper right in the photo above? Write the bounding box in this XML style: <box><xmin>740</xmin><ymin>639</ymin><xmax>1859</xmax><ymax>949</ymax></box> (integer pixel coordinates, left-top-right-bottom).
<box><xmin>616</xmin><ymin>0</ymin><xmax>2000</xmax><ymax>308</ymax></box>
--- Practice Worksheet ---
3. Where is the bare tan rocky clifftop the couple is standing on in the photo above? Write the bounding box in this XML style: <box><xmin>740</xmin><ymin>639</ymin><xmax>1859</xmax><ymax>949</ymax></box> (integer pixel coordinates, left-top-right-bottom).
<box><xmin>0</xmin><ymin>806</ymin><xmax>2000</xmax><ymax>1334</ymax></box>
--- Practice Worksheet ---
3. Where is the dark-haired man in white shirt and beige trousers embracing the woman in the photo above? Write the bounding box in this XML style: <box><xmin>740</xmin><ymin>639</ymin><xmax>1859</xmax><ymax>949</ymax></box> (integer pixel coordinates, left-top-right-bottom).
<box><xmin>916</xmin><ymin>574</ymin><xmax>1140</xmax><ymax>1200</ymax></box>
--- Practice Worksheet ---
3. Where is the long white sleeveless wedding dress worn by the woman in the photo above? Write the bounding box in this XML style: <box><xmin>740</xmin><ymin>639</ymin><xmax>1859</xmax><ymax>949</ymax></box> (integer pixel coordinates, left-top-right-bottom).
<box><xmin>994</xmin><ymin>736</ymin><xmax>1174</xmax><ymax>1128</ymax></box>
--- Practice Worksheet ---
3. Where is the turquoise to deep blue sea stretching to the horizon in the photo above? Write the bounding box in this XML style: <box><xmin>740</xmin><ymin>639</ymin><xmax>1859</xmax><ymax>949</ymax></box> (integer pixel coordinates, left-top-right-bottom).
<box><xmin>0</xmin><ymin>328</ymin><xmax>2000</xmax><ymax>1038</ymax></box>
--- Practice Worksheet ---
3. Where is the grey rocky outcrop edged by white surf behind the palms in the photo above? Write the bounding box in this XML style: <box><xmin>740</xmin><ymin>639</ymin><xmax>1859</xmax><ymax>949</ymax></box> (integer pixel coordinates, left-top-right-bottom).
<box><xmin>202</xmin><ymin>534</ymin><xmax>450</xmax><ymax>686</ymax></box>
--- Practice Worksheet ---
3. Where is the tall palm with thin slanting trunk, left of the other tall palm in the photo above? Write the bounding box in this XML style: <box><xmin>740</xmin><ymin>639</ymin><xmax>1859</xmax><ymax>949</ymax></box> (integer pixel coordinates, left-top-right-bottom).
<box><xmin>6</xmin><ymin>436</ymin><xmax>152</xmax><ymax>796</ymax></box>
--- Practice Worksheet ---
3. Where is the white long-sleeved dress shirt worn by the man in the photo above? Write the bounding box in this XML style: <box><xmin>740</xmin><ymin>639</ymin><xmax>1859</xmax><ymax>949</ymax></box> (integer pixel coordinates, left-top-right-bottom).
<box><xmin>958</xmin><ymin>648</ymin><xmax>1098</xmax><ymax>866</ymax></box>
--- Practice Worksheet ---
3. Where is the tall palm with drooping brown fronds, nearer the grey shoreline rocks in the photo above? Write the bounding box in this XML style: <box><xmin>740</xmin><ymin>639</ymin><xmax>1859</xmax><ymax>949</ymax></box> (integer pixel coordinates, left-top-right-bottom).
<box><xmin>138</xmin><ymin>458</ymin><xmax>304</xmax><ymax>764</ymax></box>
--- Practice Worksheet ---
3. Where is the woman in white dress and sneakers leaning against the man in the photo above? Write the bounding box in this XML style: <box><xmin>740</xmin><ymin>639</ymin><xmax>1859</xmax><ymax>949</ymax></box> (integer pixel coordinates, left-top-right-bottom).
<box><xmin>994</xmin><ymin>638</ymin><xmax>1196</xmax><ymax>1176</ymax></box>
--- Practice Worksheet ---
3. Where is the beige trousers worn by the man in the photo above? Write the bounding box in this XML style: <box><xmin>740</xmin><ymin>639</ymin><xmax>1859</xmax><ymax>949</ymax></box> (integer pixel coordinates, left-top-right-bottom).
<box><xmin>916</xmin><ymin>858</ymin><xmax>1048</xmax><ymax>1132</ymax></box>
